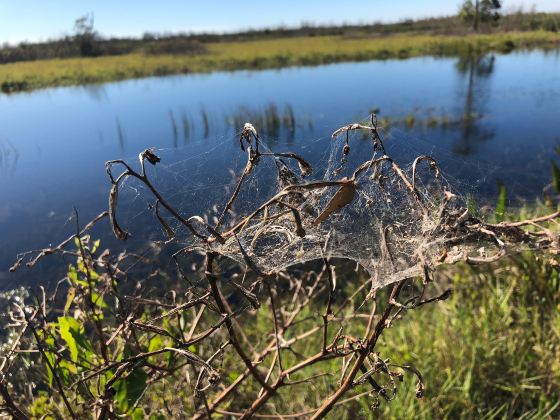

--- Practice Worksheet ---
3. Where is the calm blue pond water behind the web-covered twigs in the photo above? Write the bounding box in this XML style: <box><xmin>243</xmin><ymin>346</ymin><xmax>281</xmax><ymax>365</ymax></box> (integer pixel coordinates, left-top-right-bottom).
<box><xmin>0</xmin><ymin>51</ymin><xmax>560</xmax><ymax>289</ymax></box>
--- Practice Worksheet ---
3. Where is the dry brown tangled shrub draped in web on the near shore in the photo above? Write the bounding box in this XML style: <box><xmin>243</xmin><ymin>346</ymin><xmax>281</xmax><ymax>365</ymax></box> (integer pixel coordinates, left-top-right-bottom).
<box><xmin>5</xmin><ymin>116</ymin><xmax>560</xmax><ymax>419</ymax></box>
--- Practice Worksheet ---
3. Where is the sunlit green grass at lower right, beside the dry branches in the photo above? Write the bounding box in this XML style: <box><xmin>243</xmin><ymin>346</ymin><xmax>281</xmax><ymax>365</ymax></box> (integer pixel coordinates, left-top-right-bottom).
<box><xmin>215</xmin><ymin>256</ymin><xmax>560</xmax><ymax>420</ymax></box>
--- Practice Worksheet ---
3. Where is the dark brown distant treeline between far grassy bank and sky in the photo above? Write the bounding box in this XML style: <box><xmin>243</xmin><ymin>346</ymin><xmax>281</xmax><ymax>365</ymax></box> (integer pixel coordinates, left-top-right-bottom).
<box><xmin>0</xmin><ymin>12</ymin><xmax>560</xmax><ymax>64</ymax></box>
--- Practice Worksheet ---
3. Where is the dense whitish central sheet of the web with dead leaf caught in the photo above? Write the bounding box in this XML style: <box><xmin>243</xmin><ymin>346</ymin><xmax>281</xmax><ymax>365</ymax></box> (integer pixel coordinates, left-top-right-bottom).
<box><xmin>212</xmin><ymin>128</ymin><xmax>444</xmax><ymax>287</ymax></box>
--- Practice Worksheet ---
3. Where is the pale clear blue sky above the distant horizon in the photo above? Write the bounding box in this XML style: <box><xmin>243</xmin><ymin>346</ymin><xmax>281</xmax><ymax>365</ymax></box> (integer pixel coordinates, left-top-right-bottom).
<box><xmin>0</xmin><ymin>0</ymin><xmax>560</xmax><ymax>43</ymax></box>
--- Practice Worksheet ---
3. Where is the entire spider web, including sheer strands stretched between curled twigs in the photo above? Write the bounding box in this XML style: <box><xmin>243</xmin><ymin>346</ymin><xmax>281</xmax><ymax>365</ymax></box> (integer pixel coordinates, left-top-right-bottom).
<box><xmin>110</xmin><ymin>115</ymin><xmax>508</xmax><ymax>287</ymax></box>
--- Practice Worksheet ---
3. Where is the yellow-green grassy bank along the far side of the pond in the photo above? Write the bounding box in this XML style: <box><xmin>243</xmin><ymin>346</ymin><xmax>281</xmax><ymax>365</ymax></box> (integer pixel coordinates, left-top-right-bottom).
<box><xmin>0</xmin><ymin>31</ymin><xmax>560</xmax><ymax>93</ymax></box>
